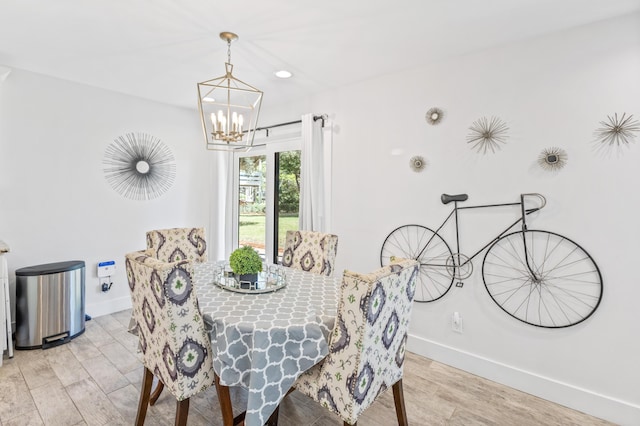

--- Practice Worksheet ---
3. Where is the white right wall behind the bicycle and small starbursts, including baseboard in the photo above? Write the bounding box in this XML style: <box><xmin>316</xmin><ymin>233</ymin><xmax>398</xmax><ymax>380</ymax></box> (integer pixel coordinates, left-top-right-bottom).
<box><xmin>262</xmin><ymin>15</ymin><xmax>640</xmax><ymax>424</ymax></box>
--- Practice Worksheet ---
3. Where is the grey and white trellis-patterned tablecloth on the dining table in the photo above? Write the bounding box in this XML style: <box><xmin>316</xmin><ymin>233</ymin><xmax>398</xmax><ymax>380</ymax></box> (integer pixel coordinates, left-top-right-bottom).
<box><xmin>195</xmin><ymin>263</ymin><xmax>341</xmax><ymax>426</ymax></box>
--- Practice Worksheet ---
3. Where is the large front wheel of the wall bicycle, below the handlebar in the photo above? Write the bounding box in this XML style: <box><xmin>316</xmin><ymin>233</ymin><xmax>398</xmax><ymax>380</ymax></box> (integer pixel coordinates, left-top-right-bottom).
<box><xmin>482</xmin><ymin>231</ymin><xmax>602</xmax><ymax>328</ymax></box>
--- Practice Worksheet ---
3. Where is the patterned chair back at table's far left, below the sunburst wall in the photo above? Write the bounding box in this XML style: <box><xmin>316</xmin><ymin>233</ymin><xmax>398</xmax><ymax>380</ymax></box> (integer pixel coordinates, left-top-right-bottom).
<box><xmin>147</xmin><ymin>228</ymin><xmax>207</xmax><ymax>262</ymax></box>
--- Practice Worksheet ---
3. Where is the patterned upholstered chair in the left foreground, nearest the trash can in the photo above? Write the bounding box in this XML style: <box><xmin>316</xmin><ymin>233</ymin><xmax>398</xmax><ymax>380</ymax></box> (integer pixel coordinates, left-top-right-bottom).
<box><xmin>125</xmin><ymin>250</ymin><xmax>215</xmax><ymax>425</ymax></box>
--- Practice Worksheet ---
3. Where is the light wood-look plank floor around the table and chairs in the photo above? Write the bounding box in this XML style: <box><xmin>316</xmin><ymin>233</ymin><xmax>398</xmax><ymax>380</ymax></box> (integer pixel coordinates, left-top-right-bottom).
<box><xmin>0</xmin><ymin>311</ymin><xmax>610</xmax><ymax>426</ymax></box>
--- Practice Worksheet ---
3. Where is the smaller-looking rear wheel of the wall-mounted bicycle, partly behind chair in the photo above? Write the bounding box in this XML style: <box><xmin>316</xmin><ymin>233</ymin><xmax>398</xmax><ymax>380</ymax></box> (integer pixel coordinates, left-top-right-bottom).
<box><xmin>380</xmin><ymin>225</ymin><xmax>455</xmax><ymax>302</ymax></box>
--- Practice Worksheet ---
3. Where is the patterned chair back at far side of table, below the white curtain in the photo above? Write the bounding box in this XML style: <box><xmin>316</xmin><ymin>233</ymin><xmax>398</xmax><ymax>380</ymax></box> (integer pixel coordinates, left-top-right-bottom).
<box><xmin>282</xmin><ymin>231</ymin><xmax>338</xmax><ymax>276</ymax></box>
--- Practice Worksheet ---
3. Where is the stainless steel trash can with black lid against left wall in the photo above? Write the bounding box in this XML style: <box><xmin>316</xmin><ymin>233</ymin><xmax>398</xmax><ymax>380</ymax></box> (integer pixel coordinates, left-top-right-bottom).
<box><xmin>15</xmin><ymin>260</ymin><xmax>85</xmax><ymax>349</ymax></box>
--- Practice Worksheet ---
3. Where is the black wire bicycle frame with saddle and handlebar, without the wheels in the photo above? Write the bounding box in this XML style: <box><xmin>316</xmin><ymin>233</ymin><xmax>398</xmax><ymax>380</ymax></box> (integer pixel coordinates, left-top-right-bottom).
<box><xmin>417</xmin><ymin>193</ymin><xmax>547</xmax><ymax>280</ymax></box>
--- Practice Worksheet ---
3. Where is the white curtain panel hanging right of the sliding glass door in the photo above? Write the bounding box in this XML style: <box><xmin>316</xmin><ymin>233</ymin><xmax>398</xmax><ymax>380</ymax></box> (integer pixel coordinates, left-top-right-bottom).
<box><xmin>300</xmin><ymin>114</ymin><xmax>332</xmax><ymax>232</ymax></box>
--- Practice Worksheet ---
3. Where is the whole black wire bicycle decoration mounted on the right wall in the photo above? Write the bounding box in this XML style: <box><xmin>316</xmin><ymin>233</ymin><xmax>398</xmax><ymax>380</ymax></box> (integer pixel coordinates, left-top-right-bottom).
<box><xmin>380</xmin><ymin>193</ymin><xmax>602</xmax><ymax>328</ymax></box>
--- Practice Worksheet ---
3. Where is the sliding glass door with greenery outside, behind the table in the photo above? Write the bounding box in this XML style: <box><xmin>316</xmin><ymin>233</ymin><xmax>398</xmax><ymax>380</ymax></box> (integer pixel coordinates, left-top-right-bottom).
<box><xmin>234</xmin><ymin>139</ymin><xmax>300</xmax><ymax>263</ymax></box>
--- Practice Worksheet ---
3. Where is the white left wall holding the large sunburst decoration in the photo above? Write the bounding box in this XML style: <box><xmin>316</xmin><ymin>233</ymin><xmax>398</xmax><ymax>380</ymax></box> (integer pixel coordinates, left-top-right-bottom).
<box><xmin>0</xmin><ymin>69</ymin><xmax>210</xmax><ymax>316</ymax></box>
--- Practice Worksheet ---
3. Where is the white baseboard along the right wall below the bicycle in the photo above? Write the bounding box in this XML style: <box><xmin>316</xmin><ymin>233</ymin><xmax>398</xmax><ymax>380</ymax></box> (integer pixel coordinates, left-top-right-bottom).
<box><xmin>407</xmin><ymin>335</ymin><xmax>640</xmax><ymax>425</ymax></box>
